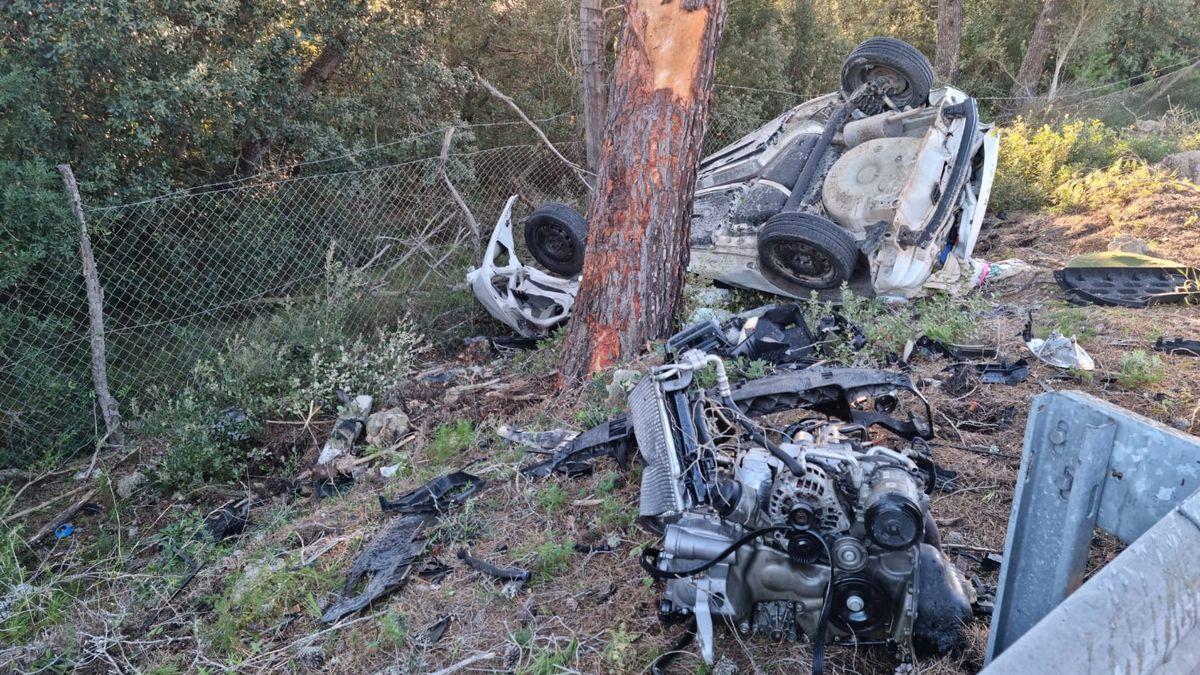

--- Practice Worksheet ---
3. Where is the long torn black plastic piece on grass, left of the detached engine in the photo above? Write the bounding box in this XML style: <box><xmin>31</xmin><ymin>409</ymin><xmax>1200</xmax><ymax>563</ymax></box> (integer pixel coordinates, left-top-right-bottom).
<box><xmin>320</xmin><ymin>514</ymin><xmax>432</xmax><ymax>623</ymax></box>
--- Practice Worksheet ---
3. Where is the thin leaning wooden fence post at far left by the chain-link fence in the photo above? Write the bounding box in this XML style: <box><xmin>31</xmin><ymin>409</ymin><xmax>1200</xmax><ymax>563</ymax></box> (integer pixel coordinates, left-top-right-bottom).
<box><xmin>59</xmin><ymin>165</ymin><xmax>125</xmax><ymax>449</ymax></box>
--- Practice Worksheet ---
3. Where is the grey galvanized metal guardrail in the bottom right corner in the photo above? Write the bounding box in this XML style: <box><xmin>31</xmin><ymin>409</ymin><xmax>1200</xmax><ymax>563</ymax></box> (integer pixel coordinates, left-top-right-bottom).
<box><xmin>984</xmin><ymin>392</ymin><xmax>1200</xmax><ymax>675</ymax></box>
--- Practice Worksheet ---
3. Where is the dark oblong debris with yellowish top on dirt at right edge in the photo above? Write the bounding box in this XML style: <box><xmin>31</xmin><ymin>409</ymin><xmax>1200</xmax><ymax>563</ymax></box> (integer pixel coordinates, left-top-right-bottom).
<box><xmin>1054</xmin><ymin>251</ymin><xmax>1200</xmax><ymax>307</ymax></box>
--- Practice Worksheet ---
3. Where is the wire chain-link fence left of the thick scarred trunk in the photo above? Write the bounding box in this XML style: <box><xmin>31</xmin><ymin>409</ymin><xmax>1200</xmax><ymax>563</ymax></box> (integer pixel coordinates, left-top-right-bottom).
<box><xmin>0</xmin><ymin>123</ymin><xmax>604</xmax><ymax>464</ymax></box>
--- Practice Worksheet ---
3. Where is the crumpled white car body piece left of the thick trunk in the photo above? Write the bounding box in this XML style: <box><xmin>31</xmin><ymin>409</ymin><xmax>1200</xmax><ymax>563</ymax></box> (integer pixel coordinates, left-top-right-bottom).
<box><xmin>467</xmin><ymin>195</ymin><xmax>580</xmax><ymax>338</ymax></box>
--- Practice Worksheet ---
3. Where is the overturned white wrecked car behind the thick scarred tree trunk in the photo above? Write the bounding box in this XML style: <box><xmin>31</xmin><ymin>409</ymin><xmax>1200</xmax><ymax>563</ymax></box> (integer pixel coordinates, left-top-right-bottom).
<box><xmin>468</xmin><ymin>37</ymin><xmax>1000</xmax><ymax>335</ymax></box>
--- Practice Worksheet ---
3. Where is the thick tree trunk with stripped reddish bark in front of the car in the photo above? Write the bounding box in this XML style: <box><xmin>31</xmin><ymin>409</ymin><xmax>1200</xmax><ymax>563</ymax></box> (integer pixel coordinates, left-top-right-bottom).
<box><xmin>559</xmin><ymin>0</ymin><xmax>725</xmax><ymax>384</ymax></box>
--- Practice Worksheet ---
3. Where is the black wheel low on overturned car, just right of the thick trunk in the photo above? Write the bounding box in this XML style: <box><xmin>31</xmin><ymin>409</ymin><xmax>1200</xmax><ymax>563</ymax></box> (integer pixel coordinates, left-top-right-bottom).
<box><xmin>758</xmin><ymin>211</ymin><xmax>858</xmax><ymax>291</ymax></box>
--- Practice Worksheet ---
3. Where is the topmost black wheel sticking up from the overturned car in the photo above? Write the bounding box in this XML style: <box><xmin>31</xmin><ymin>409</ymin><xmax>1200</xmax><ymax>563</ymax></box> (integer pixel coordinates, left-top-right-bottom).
<box><xmin>841</xmin><ymin>37</ymin><xmax>934</xmax><ymax>114</ymax></box>
